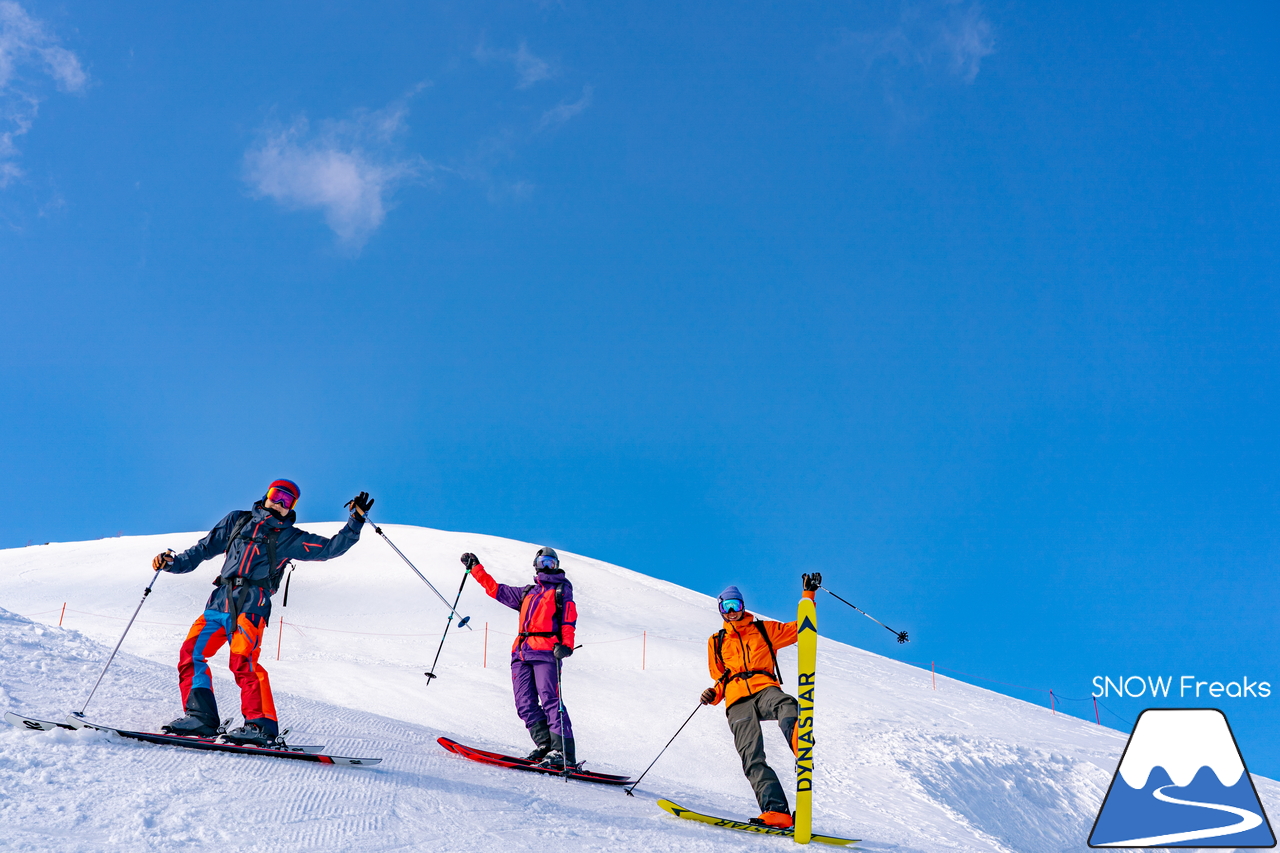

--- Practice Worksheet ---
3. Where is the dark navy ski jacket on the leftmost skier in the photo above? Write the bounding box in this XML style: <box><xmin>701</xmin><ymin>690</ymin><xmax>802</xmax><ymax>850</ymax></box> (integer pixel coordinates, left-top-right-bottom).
<box><xmin>165</xmin><ymin>501</ymin><xmax>365</xmax><ymax>617</ymax></box>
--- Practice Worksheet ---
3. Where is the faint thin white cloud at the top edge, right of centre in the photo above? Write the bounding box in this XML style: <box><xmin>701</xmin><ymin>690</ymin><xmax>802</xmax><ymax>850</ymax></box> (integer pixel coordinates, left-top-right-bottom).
<box><xmin>844</xmin><ymin>0</ymin><xmax>996</xmax><ymax>83</ymax></box>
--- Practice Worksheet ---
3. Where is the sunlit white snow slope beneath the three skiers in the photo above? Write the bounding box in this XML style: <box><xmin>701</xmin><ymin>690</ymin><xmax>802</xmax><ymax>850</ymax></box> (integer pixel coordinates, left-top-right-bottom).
<box><xmin>0</xmin><ymin>524</ymin><xmax>1280</xmax><ymax>853</ymax></box>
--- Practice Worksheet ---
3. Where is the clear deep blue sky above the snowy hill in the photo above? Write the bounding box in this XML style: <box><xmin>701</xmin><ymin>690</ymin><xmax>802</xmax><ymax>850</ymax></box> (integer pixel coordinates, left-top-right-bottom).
<box><xmin>0</xmin><ymin>0</ymin><xmax>1280</xmax><ymax>777</ymax></box>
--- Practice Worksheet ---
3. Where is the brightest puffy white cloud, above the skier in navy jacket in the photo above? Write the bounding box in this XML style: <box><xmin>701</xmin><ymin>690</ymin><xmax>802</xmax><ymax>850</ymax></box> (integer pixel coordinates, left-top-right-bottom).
<box><xmin>244</xmin><ymin>101</ymin><xmax>431</xmax><ymax>250</ymax></box>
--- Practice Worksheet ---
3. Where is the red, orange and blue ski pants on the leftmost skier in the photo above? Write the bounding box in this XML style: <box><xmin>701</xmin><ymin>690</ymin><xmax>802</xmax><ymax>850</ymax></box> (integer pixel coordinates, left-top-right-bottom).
<box><xmin>178</xmin><ymin>610</ymin><xmax>276</xmax><ymax>720</ymax></box>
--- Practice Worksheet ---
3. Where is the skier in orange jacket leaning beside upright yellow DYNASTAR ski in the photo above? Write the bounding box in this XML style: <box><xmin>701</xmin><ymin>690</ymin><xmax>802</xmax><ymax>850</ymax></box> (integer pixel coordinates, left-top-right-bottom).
<box><xmin>701</xmin><ymin>573</ymin><xmax>822</xmax><ymax>829</ymax></box>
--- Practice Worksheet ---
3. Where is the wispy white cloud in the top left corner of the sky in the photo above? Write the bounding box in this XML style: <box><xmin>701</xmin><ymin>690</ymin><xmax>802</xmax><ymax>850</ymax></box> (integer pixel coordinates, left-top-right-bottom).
<box><xmin>0</xmin><ymin>0</ymin><xmax>88</xmax><ymax>188</ymax></box>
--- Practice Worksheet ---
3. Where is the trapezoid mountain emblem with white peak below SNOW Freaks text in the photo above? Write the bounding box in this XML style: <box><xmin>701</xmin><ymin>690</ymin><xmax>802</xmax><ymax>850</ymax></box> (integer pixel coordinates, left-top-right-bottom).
<box><xmin>1089</xmin><ymin>708</ymin><xmax>1276</xmax><ymax>848</ymax></box>
